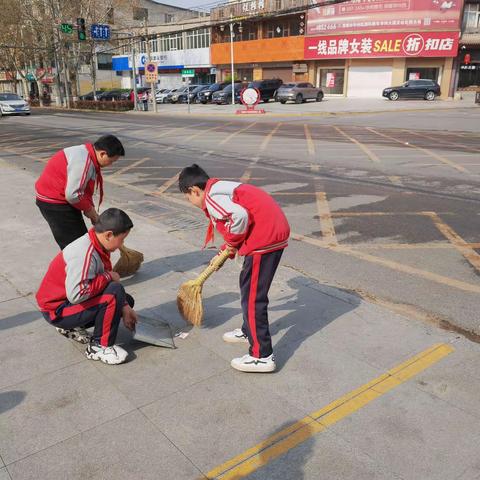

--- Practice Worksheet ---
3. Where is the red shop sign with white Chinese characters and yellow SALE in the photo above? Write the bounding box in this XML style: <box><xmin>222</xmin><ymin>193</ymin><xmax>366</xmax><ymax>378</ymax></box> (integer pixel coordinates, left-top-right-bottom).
<box><xmin>305</xmin><ymin>32</ymin><xmax>459</xmax><ymax>59</ymax></box>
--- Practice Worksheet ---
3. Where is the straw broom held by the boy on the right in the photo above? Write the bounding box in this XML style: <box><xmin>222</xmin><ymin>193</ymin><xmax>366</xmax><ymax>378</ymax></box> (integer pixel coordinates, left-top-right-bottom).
<box><xmin>177</xmin><ymin>248</ymin><xmax>231</xmax><ymax>327</ymax></box>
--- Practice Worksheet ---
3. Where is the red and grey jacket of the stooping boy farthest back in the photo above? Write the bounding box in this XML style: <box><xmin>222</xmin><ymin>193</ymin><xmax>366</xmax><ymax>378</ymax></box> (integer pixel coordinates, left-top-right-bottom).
<box><xmin>35</xmin><ymin>143</ymin><xmax>103</xmax><ymax>211</ymax></box>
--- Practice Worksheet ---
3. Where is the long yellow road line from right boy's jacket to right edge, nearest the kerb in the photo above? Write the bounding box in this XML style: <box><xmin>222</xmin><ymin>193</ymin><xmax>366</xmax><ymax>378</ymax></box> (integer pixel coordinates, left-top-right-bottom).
<box><xmin>291</xmin><ymin>233</ymin><xmax>480</xmax><ymax>293</ymax></box>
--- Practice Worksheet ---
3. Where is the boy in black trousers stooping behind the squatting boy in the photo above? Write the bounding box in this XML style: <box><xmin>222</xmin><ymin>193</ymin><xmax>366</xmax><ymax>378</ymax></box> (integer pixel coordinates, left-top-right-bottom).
<box><xmin>35</xmin><ymin>135</ymin><xmax>125</xmax><ymax>250</ymax></box>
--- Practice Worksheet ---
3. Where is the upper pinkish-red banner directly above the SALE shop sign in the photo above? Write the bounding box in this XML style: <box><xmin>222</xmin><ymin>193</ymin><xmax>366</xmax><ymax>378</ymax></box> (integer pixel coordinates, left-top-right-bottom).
<box><xmin>307</xmin><ymin>0</ymin><xmax>463</xmax><ymax>35</ymax></box>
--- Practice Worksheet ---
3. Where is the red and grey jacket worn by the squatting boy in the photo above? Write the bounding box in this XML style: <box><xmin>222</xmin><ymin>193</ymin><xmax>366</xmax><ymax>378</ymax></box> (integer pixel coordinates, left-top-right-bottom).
<box><xmin>36</xmin><ymin>228</ymin><xmax>112</xmax><ymax>321</ymax></box>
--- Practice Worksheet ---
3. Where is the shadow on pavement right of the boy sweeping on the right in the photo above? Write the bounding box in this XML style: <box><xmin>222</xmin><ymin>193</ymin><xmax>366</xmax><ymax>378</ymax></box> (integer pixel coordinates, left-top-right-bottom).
<box><xmin>269</xmin><ymin>277</ymin><xmax>360</xmax><ymax>370</ymax></box>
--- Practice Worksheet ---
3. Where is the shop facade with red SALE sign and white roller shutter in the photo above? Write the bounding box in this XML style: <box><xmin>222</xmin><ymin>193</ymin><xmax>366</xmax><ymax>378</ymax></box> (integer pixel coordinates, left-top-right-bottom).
<box><xmin>305</xmin><ymin>0</ymin><xmax>462</xmax><ymax>98</ymax></box>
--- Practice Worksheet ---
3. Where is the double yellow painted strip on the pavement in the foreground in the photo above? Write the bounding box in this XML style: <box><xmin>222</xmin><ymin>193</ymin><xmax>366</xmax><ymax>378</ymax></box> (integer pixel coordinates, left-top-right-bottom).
<box><xmin>205</xmin><ymin>343</ymin><xmax>454</xmax><ymax>480</ymax></box>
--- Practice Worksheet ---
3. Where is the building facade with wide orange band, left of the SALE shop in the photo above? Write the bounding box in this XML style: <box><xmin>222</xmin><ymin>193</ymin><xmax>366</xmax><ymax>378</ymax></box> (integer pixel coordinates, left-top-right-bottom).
<box><xmin>211</xmin><ymin>0</ymin><xmax>308</xmax><ymax>82</ymax></box>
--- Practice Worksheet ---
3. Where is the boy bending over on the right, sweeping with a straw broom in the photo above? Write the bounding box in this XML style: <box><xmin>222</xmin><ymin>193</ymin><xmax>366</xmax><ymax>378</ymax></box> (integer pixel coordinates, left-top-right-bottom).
<box><xmin>179</xmin><ymin>164</ymin><xmax>290</xmax><ymax>372</ymax></box>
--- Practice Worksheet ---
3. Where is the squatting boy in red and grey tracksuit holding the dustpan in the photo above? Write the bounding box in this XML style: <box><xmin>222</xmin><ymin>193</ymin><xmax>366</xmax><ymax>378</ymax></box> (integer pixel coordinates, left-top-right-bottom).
<box><xmin>36</xmin><ymin>208</ymin><xmax>137</xmax><ymax>365</ymax></box>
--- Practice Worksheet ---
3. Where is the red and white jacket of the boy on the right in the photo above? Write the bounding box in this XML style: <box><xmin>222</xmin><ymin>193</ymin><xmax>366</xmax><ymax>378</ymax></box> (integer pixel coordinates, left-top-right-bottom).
<box><xmin>203</xmin><ymin>178</ymin><xmax>290</xmax><ymax>256</ymax></box>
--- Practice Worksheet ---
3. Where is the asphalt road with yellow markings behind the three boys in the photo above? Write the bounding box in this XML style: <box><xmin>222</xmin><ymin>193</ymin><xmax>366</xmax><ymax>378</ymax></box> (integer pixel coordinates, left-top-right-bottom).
<box><xmin>0</xmin><ymin>109</ymin><xmax>480</xmax><ymax>338</ymax></box>
